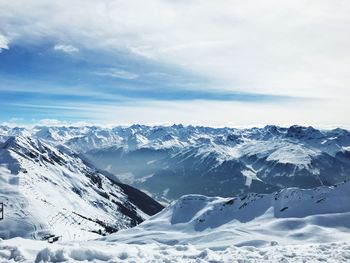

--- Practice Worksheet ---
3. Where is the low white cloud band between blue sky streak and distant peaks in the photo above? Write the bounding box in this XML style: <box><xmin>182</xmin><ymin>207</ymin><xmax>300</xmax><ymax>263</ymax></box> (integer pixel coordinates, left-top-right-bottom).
<box><xmin>6</xmin><ymin>98</ymin><xmax>350</xmax><ymax>129</ymax></box>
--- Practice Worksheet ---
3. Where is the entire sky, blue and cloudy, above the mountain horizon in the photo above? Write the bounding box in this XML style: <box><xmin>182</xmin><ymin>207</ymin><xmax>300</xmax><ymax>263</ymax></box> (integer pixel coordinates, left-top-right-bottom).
<box><xmin>0</xmin><ymin>0</ymin><xmax>350</xmax><ymax>127</ymax></box>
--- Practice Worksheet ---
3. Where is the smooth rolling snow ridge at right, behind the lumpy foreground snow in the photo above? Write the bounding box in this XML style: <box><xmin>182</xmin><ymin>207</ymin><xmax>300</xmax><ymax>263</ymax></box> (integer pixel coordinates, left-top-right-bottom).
<box><xmin>103</xmin><ymin>181</ymin><xmax>350</xmax><ymax>249</ymax></box>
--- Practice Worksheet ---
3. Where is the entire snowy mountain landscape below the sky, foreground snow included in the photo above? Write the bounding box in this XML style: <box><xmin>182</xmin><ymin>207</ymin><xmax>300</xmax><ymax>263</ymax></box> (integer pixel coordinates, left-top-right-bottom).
<box><xmin>0</xmin><ymin>125</ymin><xmax>350</xmax><ymax>262</ymax></box>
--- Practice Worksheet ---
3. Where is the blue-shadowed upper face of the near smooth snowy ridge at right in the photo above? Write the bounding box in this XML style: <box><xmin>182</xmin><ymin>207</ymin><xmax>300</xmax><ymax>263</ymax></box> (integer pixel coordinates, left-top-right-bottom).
<box><xmin>152</xmin><ymin>181</ymin><xmax>350</xmax><ymax>231</ymax></box>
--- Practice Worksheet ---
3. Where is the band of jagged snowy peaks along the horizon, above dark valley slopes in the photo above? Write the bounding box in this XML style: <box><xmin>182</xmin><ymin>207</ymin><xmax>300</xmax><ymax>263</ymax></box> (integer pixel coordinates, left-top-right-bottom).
<box><xmin>0</xmin><ymin>125</ymin><xmax>350</xmax><ymax>153</ymax></box>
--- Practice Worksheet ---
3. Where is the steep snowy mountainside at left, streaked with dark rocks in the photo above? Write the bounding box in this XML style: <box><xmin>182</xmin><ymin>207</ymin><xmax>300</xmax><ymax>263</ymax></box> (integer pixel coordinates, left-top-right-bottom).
<box><xmin>0</xmin><ymin>136</ymin><xmax>162</xmax><ymax>240</ymax></box>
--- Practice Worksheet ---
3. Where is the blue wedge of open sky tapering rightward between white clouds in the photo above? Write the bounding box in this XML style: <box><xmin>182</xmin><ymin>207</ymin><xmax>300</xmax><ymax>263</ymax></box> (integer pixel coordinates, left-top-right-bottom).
<box><xmin>0</xmin><ymin>43</ymin><xmax>295</xmax><ymax>122</ymax></box>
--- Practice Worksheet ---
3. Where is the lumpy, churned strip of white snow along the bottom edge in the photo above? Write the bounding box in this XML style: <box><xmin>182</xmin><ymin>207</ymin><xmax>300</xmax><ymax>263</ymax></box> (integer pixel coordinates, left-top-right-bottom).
<box><xmin>0</xmin><ymin>238</ymin><xmax>350</xmax><ymax>263</ymax></box>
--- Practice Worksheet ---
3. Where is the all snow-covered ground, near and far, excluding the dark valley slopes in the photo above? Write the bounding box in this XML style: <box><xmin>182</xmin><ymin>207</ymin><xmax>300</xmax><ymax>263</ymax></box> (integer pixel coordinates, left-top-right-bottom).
<box><xmin>0</xmin><ymin>125</ymin><xmax>350</xmax><ymax>262</ymax></box>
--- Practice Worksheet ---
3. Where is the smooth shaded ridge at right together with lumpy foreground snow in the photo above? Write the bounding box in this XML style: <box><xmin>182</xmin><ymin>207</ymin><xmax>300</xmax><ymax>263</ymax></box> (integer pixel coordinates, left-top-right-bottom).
<box><xmin>0</xmin><ymin>181</ymin><xmax>350</xmax><ymax>263</ymax></box>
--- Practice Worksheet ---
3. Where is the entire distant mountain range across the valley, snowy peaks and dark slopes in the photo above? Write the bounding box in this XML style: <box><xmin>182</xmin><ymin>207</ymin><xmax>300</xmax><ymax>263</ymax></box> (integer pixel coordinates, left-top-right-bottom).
<box><xmin>0</xmin><ymin>125</ymin><xmax>350</xmax><ymax>202</ymax></box>
